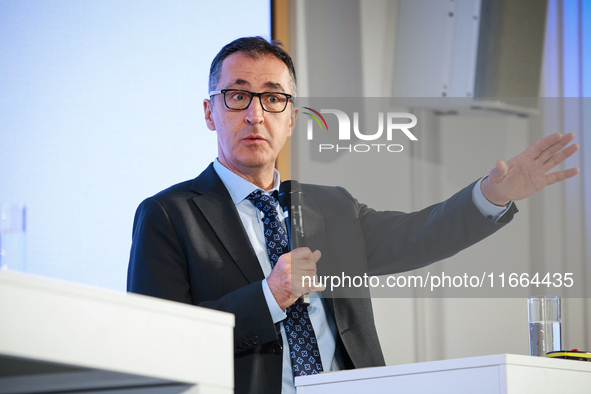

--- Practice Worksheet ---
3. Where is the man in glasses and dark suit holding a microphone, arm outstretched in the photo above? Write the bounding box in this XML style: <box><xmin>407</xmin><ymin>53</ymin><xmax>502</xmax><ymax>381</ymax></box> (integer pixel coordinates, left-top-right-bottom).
<box><xmin>128</xmin><ymin>37</ymin><xmax>578</xmax><ymax>393</ymax></box>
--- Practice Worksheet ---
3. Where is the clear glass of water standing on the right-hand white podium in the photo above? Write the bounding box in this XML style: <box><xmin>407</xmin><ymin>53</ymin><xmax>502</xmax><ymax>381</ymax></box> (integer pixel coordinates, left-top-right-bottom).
<box><xmin>527</xmin><ymin>296</ymin><xmax>562</xmax><ymax>357</ymax></box>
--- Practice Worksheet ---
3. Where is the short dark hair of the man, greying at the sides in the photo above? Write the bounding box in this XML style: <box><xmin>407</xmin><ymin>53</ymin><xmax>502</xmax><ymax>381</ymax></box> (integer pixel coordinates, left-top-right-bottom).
<box><xmin>209</xmin><ymin>37</ymin><xmax>297</xmax><ymax>96</ymax></box>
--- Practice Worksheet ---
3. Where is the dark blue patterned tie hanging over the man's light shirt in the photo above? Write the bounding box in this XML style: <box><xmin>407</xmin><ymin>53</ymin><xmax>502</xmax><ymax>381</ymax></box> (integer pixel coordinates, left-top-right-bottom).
<box><xmin>248</xmin><ymin>190</ymin><xmax>322</xmax><ymax>376</ymax></box>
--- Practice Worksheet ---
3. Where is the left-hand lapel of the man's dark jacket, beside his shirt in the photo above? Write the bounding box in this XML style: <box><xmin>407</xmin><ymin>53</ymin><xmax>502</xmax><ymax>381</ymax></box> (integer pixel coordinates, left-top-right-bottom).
<box><xmin>191</xmin><ymin>165</ymin><xmax>265</xmax><ymax>283</ymax></box>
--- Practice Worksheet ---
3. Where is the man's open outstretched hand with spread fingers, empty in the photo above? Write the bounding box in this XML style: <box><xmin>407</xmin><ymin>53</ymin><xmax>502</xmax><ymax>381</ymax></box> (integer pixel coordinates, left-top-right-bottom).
<box><xmin>480</xmin><ymin>133</ymin><xmax>579</xmax><ymax>205</ymax></box>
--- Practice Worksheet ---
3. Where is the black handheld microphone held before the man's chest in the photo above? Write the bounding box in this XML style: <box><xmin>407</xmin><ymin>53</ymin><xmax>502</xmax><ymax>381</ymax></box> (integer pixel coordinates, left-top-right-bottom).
<box><xmin>279</xmin><ymin>180</ymin><xmax>310</xmax><ymax>307</ymax></box>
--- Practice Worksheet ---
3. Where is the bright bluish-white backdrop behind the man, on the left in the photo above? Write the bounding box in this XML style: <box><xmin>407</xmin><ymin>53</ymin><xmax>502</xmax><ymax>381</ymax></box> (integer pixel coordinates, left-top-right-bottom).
<box><xmin>0</xmin><ymin>0</ymin><xmax>270</xmax><ymax>290</ymax></box>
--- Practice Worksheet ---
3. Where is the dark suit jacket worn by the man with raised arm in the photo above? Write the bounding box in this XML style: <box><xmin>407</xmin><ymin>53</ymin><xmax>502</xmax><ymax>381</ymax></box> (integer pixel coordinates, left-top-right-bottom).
<box><xmin>127</xmin><ymin>165</ymin><xmax>514</xmax><ymax>393</ymax></box>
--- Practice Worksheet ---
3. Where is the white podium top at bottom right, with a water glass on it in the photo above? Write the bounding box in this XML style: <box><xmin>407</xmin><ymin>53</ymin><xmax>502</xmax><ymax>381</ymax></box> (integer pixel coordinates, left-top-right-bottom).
<box><xmin>296</xmin><ymin>354</ymin><xmax>591</xmax><ymax>394</ymax></box>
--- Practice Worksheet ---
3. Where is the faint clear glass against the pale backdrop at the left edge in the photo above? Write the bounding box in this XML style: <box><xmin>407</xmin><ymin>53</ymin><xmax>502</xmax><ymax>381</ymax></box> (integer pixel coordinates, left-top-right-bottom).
<box><xmin>0</xmin><ymin>203</ymin><xmax>27</xmax><ymax>271</ymax></box>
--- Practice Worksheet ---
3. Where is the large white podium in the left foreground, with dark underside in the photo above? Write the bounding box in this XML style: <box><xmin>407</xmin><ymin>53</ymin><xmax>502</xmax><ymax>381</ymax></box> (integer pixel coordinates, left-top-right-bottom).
<box><xmin>0</xmin><ymin>271</ymin><xmax>234</xmax><ymax>394</ymax></box>
